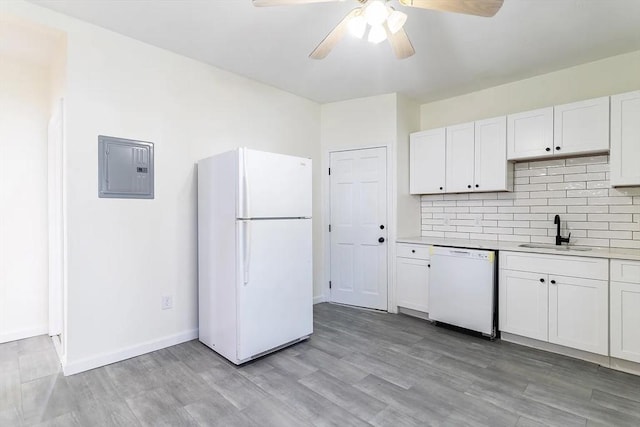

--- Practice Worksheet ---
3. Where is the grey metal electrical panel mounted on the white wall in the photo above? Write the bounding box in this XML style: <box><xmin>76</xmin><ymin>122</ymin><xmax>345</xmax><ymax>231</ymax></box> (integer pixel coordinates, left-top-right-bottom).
<box><xmin>98</xmin><ymin>135</ymin><xmax>154</xmax><ymax>199</ymax></box>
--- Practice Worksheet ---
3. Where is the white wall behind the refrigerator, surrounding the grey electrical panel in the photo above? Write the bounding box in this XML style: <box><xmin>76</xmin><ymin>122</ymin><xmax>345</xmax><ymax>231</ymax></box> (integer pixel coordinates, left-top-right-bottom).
<box><xmin>0</xmin><ymin>2</ymin><xmax>321</xmax><ymax>373</ymax></box>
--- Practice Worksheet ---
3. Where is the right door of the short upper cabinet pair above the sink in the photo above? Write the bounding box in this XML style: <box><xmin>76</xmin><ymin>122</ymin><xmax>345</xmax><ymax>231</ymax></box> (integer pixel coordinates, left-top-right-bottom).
<box><xmin>553</xmin><ymin>96</ymin><xmax>609</xmax><ymax>155</ymax></box>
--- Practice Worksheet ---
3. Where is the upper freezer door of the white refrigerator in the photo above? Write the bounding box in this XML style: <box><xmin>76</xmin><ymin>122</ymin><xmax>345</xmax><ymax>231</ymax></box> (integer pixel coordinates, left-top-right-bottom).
<box><xmin>237</xmin><ymin>148</ymin><xmax>311</xmax><ymax>218</ymax></box>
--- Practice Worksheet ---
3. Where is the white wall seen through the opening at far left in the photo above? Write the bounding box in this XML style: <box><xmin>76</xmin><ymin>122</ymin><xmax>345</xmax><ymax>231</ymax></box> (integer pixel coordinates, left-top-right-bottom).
<box><xmin>0</xmin><ymin>56</ymin><xmax>50</xmax><ymax>343</ymax></box>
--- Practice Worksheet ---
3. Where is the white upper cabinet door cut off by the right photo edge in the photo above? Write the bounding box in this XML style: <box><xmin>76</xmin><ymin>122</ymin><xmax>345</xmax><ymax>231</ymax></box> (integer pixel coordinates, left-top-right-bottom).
<box><xmin>611</xmin><ymin>90</ymin><xmax>640</xmax><ymax>186</ymax></box>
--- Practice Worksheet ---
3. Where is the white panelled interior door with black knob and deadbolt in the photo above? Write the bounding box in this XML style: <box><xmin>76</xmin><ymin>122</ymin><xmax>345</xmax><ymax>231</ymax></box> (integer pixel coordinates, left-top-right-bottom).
<box><xmin>329</xmin><ymin>147</ymin><xmax>387</xmax><ymax>310</ymax></box>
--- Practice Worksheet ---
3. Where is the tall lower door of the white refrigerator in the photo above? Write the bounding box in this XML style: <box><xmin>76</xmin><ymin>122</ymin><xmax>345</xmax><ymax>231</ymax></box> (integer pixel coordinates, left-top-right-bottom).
<box><xmin>237</xmin><ymin>219</ymin><xmax>313</xmax><ymax>363</ymax></box>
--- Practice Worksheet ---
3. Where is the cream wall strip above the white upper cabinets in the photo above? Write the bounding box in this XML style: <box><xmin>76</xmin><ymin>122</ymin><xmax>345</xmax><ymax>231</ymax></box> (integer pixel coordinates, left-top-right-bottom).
<box><xmin>420</xmin><ymin>51</ymin><xmax>640</xmax><ymax>130</ymax></box>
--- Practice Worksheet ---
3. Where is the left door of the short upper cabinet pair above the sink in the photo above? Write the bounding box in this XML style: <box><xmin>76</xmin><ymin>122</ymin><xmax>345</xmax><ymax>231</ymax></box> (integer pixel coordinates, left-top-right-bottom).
<box><xmin>507</xmin><ymin>107</ymin><xmax>553</xmax><ymax>160</ymax></box>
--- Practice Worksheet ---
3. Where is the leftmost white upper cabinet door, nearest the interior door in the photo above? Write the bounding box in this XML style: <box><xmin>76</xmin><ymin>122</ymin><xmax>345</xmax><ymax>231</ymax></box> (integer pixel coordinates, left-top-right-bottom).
<box><xmin>409</xmin><ymin>128</ymin><xmax>446</xmax><ymax>194</ymax></box>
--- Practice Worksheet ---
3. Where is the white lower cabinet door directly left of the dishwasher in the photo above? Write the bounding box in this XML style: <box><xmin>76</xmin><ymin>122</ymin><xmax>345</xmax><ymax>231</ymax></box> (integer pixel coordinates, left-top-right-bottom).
<box><xmin>396</xmin><ymin>258</ymin><xmax>429</xmax><ymax>313</ymax></box>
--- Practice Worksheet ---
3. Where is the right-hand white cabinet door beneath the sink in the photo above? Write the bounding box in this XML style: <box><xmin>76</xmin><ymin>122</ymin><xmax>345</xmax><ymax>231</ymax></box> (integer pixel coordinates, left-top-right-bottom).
<box><xmin>549</xmin><ymin>276</ymin><xmax>609</xmax><ymax>356</ymax></box>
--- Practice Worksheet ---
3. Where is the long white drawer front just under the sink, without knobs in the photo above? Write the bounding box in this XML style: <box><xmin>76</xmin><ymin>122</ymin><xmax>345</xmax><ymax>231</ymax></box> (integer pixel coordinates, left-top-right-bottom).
<box><xmin>500</xmin><ymin>252</ymin><xmax>609</xmax><ymax>280</ymax></box>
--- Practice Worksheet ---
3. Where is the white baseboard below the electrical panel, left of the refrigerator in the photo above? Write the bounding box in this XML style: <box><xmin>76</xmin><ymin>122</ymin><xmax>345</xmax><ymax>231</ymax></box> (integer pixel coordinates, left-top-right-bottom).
<box><xmin>62</xmin><ymin>329</ymin><xmax>198</xmax><ymax>376</ymax></box>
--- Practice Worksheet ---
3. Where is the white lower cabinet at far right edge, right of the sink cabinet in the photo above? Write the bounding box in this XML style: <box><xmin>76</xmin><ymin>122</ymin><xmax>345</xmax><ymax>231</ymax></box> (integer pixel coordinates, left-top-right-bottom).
<box><xmin>610</xmin><ymin>260</ymin><xmax>640</xmax><ymax>363</ymax></box>
